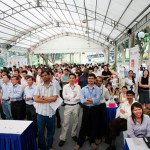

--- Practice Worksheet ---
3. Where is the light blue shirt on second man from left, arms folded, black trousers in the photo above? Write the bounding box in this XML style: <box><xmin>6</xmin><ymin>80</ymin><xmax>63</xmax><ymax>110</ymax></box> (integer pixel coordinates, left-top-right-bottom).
<box><xmin>10</xmin><ymin>84</ymin><xmax>23</xmax><ymax>101</ymax></box>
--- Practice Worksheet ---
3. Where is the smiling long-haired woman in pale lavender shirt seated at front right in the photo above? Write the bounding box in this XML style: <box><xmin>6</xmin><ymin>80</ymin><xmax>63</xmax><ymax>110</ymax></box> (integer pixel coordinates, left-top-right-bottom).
<box><xmin>127</xmin><ymin>102</ymin><xmax>150</xmax><ymax>138</ymax></box>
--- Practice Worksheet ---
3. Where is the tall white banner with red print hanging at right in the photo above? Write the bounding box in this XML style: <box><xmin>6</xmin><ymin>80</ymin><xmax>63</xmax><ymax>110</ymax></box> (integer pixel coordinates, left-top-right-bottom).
<box><xmin>130</xmin><ymin>46</ymin><xmax>139</xmax><ymax>76</ymax></box>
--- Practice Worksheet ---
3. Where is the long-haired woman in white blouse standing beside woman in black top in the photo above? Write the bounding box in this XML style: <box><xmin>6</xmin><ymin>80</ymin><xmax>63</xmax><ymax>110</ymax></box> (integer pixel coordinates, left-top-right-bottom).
<box><xmin>125</xmin><ymin>70</ymin><xmax>136</xmax><ymax>93</ymax></box>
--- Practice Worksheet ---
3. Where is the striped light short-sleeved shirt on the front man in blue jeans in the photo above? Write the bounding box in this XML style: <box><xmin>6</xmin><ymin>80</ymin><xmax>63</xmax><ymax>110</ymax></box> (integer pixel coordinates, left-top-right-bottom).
<box><xmin>34</xmin><ymin>82</ymin><xmax>59</xmax><ymax>117</ymax></box>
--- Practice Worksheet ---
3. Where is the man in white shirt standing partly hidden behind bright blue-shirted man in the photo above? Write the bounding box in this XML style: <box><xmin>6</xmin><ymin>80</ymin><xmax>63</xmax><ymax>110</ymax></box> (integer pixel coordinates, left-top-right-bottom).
<box><xmin>95</xmin><ymin>76</ymin><xmax>110</xmax><ymax>144</ymax></box>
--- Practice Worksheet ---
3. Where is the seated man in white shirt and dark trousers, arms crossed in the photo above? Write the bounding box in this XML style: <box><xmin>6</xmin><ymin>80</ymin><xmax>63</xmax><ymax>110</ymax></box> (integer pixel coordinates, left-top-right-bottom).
<box><xmin>106</xmin><ymin>90</ymin><xmax>135</xmax><ymax>150</ymax></box>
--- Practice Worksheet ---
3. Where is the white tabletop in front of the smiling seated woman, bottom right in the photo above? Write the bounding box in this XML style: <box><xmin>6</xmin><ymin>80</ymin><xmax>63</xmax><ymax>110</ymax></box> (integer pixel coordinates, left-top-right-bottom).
<box><xmin>126</xmin><ymin>138</ymin><xmax>149</xmax><ymax>150</ymax></box>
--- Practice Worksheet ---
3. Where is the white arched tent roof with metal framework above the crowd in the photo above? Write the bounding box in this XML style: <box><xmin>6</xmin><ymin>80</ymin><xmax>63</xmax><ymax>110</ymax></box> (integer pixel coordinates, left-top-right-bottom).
<box><xmin>0</xmin><ymin>0</ymin><xmax>150</xmax><ymax>49</ymax></box>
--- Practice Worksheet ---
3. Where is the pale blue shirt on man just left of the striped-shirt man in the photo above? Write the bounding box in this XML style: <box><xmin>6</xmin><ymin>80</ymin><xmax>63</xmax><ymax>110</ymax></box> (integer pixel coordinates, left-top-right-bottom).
<box><xmin>24</xmin><ymin>84</ymin><xmax>36</xmax><ymax>105</ymax></box>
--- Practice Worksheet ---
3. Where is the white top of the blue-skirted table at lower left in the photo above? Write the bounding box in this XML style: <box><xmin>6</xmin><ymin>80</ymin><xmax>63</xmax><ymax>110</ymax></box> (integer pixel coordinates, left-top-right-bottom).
<box><xmin>0</xmin><ymin>120</ymin><xmax>32</xmax><ymax>134</ymax></box>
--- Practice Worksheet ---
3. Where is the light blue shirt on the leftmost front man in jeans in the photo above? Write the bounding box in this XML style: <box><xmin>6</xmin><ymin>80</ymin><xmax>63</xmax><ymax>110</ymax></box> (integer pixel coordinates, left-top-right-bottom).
<box><xmin>2</xmin><ymin>82</ymin><xmax>13</xmax><ymax>100</ymax></box>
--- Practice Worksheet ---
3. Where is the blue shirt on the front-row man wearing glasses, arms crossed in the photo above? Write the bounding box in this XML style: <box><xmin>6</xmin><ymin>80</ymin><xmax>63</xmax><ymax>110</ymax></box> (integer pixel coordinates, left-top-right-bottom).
<box><xmin>81</xmin><ymin>85</ymin><xmax>101</xmax><ymax>106</ymax></box>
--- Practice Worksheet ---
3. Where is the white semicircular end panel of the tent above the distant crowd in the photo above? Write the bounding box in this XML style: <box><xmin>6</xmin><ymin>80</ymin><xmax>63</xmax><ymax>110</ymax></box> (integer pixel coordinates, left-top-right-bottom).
<box><xmin>34</xmin><ymin>36</ymin><xmax>103</xmax><ymax>53</ymax></box>
